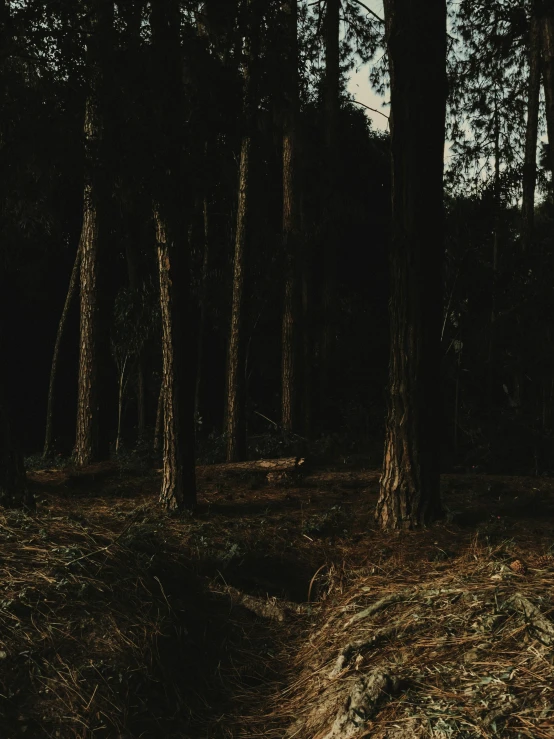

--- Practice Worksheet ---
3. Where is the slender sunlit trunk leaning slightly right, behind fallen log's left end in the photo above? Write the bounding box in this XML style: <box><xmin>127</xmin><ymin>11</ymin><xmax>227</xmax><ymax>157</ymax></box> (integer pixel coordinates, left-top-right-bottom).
<box><xmin>226</xmin><ymin>0</ymin><xmax>260</xmax><ymax>462</ymax></box>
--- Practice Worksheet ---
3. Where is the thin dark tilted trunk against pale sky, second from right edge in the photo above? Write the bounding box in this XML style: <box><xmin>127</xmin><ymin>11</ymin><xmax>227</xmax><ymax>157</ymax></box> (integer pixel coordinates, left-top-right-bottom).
<box><xmin>521</xmin><ymin>1</ymin><xmax>541</xmax><ymax>252</ymax></box>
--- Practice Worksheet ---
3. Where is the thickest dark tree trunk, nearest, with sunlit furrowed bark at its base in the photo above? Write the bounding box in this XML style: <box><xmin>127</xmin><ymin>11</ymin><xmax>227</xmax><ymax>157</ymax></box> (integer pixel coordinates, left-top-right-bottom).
<box><xmin>377</xmin><ymin>0</ymin><xmax>447</xmax><ymax>529</ymax></box>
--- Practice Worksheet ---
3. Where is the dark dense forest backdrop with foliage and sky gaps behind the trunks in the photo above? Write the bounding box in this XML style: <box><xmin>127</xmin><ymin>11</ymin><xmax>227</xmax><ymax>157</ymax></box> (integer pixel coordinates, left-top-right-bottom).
<box><xmin>1</xmin><ymin>0</ymin><xmax>554</xmax><ymax>502</ymax></box>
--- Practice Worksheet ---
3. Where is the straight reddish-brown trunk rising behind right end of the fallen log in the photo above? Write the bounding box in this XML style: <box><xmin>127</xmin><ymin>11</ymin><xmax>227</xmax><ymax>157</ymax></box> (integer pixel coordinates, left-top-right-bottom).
<box><xmin>281</xmin><ymin>0</ymin><xmax>300</xmax><ymax>431</ymax></box>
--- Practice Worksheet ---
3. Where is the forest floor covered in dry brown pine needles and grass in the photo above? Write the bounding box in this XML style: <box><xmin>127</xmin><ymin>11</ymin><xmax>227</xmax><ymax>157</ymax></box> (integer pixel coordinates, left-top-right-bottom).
<box><xmin>0</xmin><ymin>459</ymin><xmax>554</xmax><ymax>739</ymax></box>
